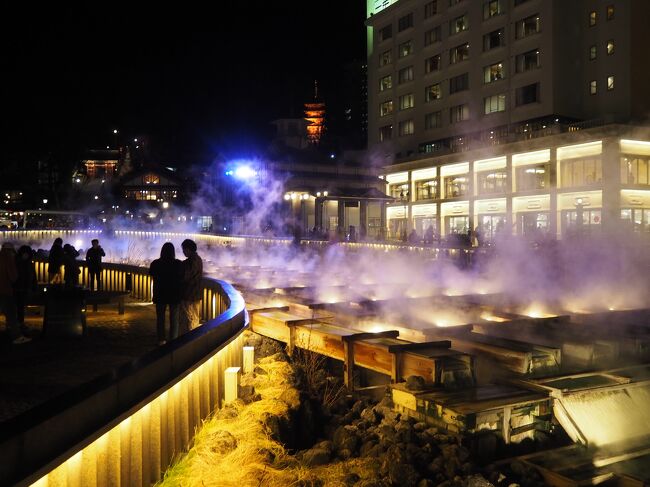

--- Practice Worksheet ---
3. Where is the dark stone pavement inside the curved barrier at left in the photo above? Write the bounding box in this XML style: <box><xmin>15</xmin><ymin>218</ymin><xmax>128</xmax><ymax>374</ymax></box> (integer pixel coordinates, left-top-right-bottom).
<box><xmin>0</xmin><ymin>301</ymin><xmax>157</xmax><ymax>427</ymax></box>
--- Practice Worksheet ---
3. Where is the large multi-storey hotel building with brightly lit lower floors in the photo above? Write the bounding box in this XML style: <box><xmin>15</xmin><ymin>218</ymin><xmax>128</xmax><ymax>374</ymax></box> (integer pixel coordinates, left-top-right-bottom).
<box><xmin>366</xmin><ymin>0</ymin><xmax>650</xmax><ymax>238</ymax></box>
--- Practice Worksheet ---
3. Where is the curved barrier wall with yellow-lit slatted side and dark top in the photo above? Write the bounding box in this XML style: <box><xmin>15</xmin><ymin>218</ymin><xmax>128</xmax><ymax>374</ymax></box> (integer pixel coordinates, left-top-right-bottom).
<box><xmin>0</xmin><ymin>262</ymin><xmax>248</xmax><ymax>487</ymax></box>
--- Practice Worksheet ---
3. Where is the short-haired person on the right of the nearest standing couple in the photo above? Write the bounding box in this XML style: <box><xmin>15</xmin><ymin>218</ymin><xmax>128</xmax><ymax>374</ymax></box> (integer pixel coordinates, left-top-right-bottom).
<box><xmin>180</xmin><ymin>239</ymin><xmax>203</xmax><ymax>333</ymax></box>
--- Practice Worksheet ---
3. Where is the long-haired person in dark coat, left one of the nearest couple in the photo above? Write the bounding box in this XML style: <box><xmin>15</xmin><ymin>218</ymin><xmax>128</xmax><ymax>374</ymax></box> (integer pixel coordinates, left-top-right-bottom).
<box><xmin>149</xmin><ymin>242</ymin><xmax>182</xmax><ymax>345</ymax></box>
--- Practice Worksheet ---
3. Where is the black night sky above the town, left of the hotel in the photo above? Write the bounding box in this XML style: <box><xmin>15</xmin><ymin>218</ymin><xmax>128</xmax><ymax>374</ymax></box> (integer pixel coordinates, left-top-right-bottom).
<box><xmin>2</xmin><ymin>0</ymin><xmax>365</xmax><ymax>165</ymax></box>
